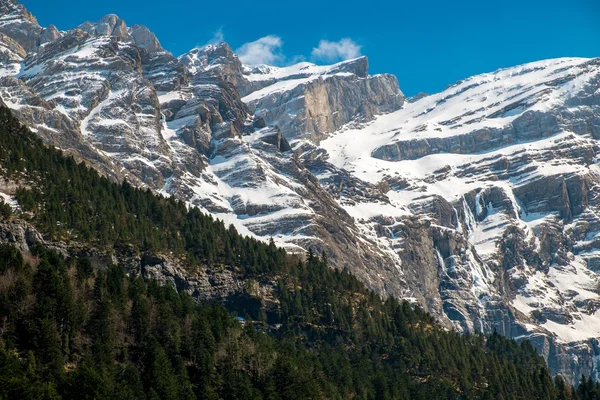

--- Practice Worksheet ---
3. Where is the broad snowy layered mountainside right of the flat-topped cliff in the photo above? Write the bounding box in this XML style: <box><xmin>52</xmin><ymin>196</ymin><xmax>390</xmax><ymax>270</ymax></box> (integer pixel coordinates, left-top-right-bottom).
<box><xmin>320</xmin><ymin>59</ymin><xmax>600</xmax><ymax>382</ymax></box>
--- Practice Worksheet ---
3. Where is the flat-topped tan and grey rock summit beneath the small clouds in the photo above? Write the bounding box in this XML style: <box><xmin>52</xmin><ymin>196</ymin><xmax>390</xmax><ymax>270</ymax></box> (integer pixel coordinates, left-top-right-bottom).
<box><xmin>241</xmin><ymin>57</ymin><xmax>404</xmax><ymax>143</ymax></box>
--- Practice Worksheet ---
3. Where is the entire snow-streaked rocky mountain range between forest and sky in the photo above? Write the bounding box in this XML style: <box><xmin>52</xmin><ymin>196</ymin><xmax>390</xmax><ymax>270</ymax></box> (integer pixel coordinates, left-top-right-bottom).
<box><xmin>0</xmin><ymin>0</ymin><xmax>600</xmax><ymax>383</ymax></box>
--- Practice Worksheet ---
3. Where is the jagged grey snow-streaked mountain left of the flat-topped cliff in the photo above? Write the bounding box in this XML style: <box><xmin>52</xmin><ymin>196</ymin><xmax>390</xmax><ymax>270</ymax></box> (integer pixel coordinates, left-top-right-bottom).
<box><xmin>0</xmin><ymin>6</ymin><xmax>410</xmax><ymax>314</ymax></box>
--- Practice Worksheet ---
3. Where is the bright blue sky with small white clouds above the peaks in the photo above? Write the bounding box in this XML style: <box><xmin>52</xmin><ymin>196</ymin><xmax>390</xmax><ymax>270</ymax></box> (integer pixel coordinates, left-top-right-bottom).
<box><xmin>22</xmin><ymin>0</ymin><xmax>600</xmax><ymax>95</ymax></box>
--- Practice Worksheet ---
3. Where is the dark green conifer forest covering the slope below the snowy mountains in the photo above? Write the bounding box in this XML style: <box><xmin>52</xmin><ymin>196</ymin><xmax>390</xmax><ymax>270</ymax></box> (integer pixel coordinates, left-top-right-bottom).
<box><xmin>0</xmin><ymin>104</ymin><xmax>600</xmax><ymax>400</ymax></box>
